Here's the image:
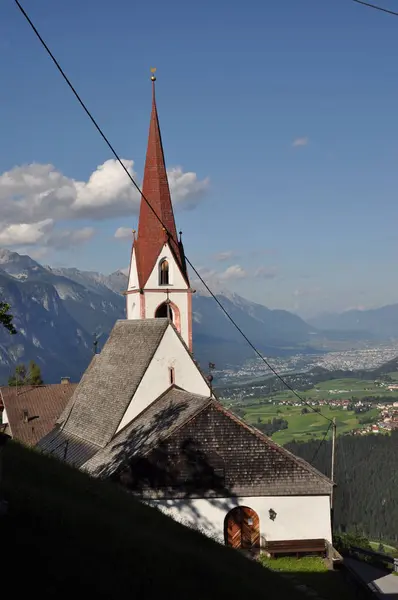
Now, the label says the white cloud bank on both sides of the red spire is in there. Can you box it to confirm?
[0,159,209,246]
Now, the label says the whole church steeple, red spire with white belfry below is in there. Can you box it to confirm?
[126,70,192,349]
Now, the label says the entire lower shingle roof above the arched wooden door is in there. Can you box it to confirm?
[82,387,333,498]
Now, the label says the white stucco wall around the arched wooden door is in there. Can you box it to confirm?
[148,496,332,543]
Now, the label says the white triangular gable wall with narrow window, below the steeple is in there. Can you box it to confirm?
[117,325,210,431]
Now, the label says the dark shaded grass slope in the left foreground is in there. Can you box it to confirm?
[0,442,304,600]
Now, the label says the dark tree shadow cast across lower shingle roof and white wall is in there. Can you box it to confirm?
[93,401,238,541]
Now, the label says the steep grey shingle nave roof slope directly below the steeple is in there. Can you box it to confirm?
[56,319,168,447]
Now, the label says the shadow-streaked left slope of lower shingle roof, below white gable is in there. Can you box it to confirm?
[84,386,211,477]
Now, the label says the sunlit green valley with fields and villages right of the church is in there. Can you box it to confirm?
[221,371,398,445]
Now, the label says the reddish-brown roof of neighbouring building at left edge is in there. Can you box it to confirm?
[0,383,77,446]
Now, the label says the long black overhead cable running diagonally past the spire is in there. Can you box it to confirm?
[15,0,332,422]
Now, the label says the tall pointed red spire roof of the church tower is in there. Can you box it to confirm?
[134,77,187,288]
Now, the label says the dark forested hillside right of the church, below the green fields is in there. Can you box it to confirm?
[286,431,398,542]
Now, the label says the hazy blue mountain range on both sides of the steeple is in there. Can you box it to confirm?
[0,249,398,383]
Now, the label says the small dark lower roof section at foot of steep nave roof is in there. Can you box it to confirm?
[36,428,100,468]
